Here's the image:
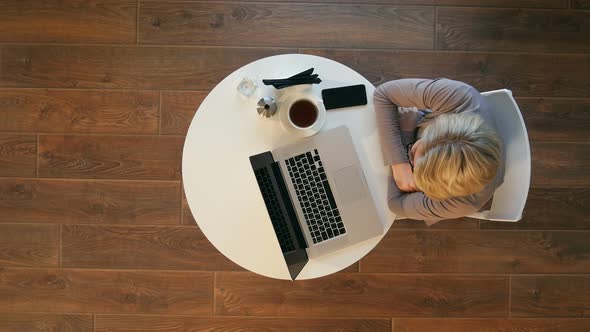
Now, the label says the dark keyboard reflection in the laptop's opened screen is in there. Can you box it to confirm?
[254,167,295,253]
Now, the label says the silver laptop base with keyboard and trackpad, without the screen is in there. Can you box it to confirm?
[272,126,383,258]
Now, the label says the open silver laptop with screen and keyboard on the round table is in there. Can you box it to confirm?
[250,126,384,280]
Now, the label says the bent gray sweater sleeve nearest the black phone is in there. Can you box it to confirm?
[373,78,477,165]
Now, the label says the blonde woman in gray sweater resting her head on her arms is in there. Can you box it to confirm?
[374,78,504,225]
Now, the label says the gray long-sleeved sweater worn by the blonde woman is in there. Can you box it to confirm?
[373,78,504,225]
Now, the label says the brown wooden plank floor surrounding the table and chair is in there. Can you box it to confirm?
[0,0,590,332]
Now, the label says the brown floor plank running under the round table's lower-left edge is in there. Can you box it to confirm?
[62,225,241,271]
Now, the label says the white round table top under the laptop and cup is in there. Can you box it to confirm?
[182,54,395,280]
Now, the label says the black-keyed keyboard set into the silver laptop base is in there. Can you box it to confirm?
[285,149,346,244]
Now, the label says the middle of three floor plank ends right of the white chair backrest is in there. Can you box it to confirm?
[531,142,590,186]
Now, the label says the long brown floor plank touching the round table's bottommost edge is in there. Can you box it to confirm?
[215,272,508,317]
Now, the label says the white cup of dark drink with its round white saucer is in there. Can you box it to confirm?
[279,91,326,137]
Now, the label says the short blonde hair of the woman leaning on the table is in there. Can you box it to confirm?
[414,113,501,200]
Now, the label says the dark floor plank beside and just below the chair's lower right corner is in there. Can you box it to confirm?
[480,187,590,230]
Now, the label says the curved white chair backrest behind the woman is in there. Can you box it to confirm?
[470,89,531,221]
